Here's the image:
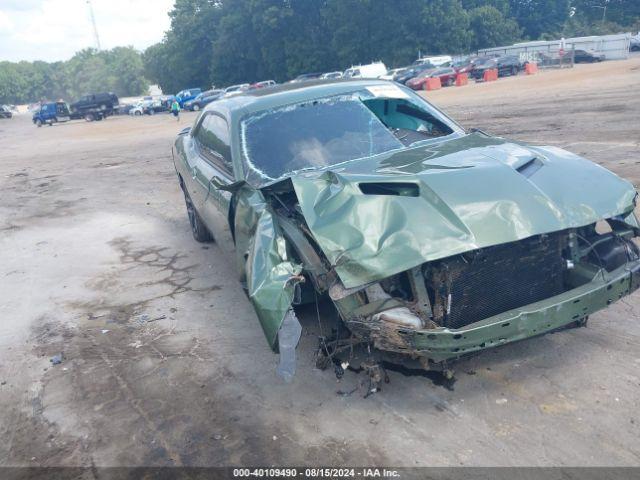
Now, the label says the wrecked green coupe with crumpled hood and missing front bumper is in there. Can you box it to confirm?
[174,80,640,378]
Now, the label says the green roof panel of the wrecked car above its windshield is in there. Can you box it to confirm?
[205,78,398,118]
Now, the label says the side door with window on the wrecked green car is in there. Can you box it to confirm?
[192,111,235,252]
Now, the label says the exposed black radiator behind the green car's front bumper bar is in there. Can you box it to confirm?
[424,232,567,328]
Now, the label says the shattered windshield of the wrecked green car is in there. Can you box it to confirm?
[241,86,457,184]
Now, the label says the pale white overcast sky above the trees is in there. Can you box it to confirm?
[0,0,174,62]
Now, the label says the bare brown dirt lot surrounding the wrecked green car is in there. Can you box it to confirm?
[0,57,640,466]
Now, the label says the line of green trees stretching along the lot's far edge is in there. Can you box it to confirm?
[0,0,640,103]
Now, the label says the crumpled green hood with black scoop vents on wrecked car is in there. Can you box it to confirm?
[291,133,636,288]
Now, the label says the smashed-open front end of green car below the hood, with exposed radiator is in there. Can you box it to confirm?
[329,219,640,368]
